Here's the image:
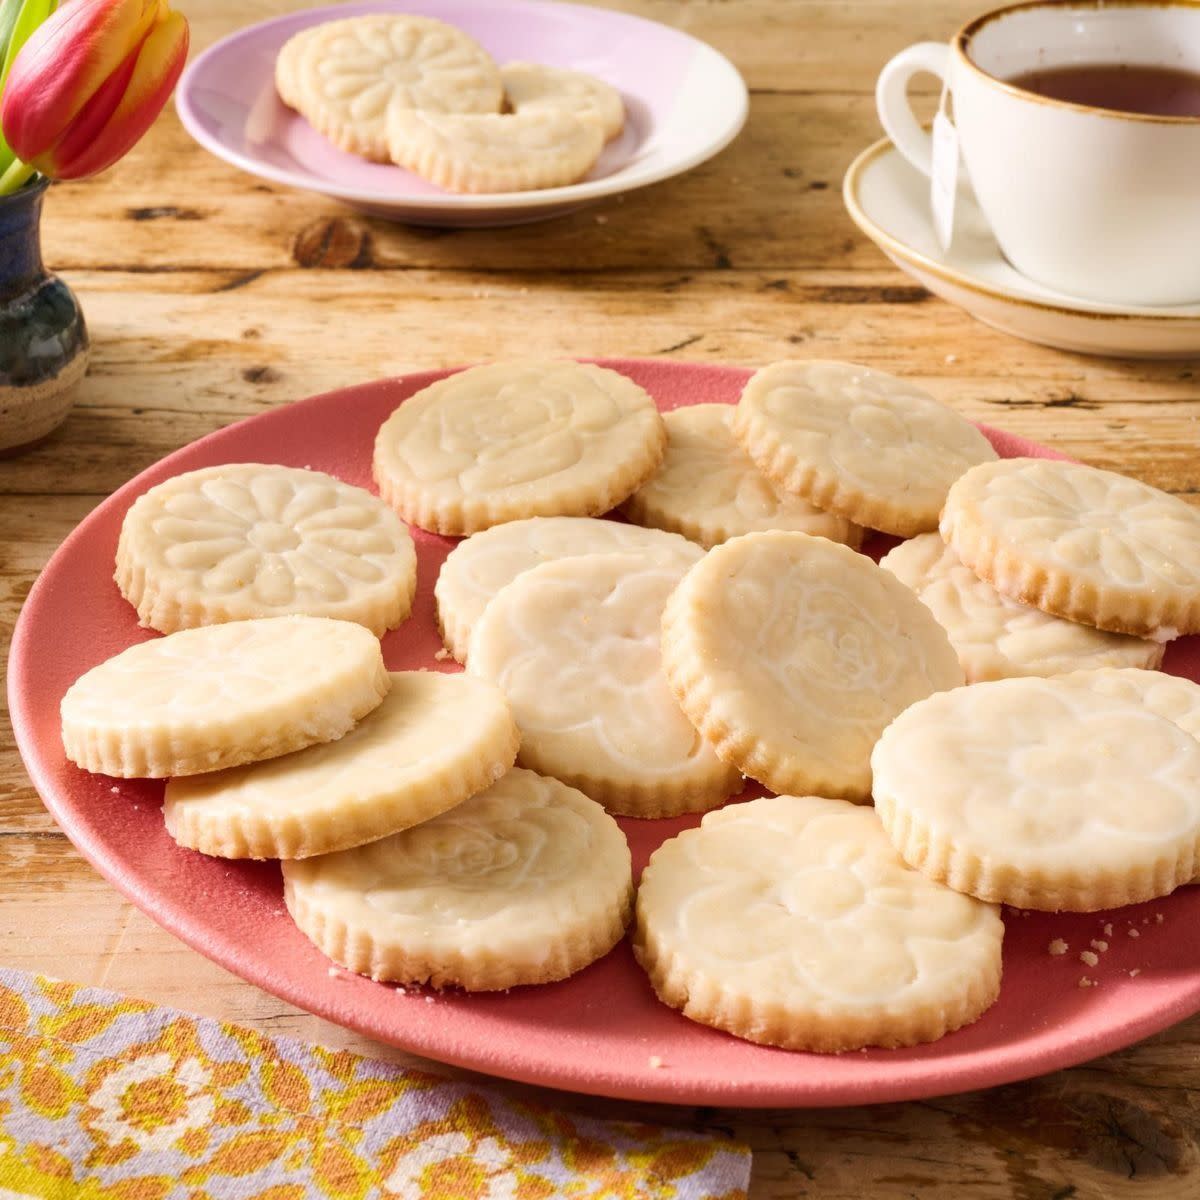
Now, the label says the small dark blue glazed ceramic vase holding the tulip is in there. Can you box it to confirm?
[0,179,88,455]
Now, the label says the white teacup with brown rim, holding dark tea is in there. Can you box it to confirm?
[875,0,1200,305]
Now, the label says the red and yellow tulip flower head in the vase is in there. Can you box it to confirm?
[0,0,187,191]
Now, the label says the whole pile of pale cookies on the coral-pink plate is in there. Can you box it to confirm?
[62,350,1200,1051]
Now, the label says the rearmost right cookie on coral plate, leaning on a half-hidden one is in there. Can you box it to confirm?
[733,359,996,538]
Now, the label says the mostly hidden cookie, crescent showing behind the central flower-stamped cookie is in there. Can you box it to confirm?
[433,517,697,662]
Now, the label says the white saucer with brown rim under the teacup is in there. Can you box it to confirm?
[842,138,1200,359]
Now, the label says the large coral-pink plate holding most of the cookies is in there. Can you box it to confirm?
[8,361,1200,1105]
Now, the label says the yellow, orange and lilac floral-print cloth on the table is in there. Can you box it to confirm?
[0,970,750,1200]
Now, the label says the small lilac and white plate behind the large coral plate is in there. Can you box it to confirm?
[175,0,748,226]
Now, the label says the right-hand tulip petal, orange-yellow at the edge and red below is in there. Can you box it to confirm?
[32,5,188,179]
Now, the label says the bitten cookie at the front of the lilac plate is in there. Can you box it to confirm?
[388,109,604,192]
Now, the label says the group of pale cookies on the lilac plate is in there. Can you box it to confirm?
[275,13,625,192]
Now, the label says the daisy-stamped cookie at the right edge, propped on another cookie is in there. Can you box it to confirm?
[941,458,1200,641]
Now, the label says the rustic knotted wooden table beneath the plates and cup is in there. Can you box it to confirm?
[0,0,1200,1200]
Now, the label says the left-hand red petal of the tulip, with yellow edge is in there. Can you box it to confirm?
[0,0,162,162]
